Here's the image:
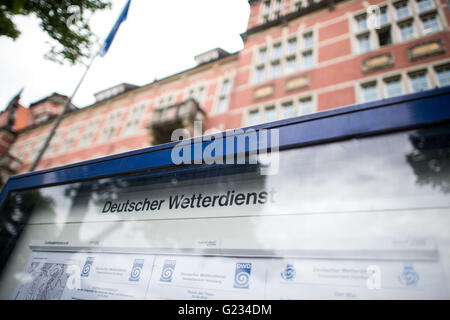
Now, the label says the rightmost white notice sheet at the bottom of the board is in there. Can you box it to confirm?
[266,259,448,299]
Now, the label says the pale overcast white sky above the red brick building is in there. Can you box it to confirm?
[0,0,250,110]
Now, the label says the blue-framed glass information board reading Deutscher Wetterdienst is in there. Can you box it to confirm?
[0,89,450,300]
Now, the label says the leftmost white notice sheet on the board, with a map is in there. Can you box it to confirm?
[13,252,154,300]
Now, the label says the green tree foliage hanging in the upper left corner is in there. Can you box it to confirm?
[0,0,111,64]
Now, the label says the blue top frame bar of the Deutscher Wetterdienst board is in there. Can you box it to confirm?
[0,86,450,204]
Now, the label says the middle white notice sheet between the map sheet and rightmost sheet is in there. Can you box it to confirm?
[149,256,267,300]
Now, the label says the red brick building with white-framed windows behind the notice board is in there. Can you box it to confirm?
[0,0,450,185]
